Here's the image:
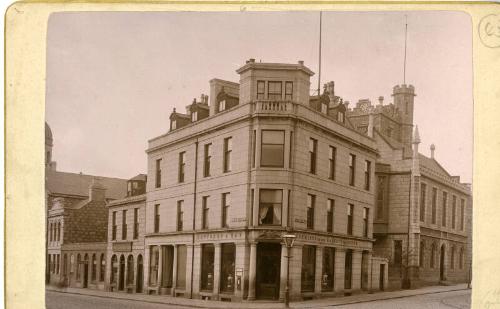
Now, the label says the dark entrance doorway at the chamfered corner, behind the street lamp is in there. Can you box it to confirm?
[255,243,281,299]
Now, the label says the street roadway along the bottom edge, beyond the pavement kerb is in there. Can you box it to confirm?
[46,290,471,309]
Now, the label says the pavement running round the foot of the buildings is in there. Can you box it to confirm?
[46,284,470,309]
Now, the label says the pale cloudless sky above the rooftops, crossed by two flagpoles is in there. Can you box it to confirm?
[46,11,473,182]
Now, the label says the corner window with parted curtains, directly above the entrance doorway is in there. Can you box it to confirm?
[259,189,283,225]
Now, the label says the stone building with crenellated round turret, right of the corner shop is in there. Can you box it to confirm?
[347,85,472,288]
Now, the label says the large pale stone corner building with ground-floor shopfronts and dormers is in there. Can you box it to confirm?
[144,59,387,300]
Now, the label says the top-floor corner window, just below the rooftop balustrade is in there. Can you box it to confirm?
[260,130,285,167]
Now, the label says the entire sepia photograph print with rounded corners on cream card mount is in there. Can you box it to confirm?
[44,10,476,309]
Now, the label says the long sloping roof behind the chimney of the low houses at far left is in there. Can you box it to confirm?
[46,170,127,199]
